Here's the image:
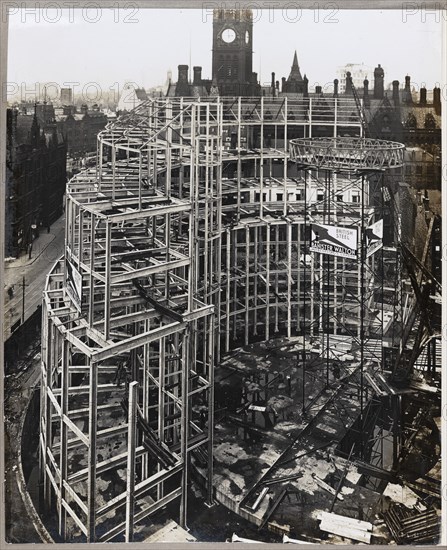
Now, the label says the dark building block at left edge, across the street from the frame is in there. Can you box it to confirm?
[5,108,67,257]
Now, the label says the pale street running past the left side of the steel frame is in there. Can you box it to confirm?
[3,214,65,341]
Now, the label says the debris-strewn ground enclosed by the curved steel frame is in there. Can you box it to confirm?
[210,339,439,544]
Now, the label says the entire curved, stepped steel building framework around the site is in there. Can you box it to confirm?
[40,98,408,541]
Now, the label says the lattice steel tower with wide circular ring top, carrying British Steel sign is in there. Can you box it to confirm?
[290,137,405,459]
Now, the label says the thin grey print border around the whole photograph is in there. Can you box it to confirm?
[0,0,447,550]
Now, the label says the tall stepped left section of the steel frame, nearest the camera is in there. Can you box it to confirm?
[41,101,221,541]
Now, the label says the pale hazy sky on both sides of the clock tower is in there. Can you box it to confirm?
[8,7,441,101]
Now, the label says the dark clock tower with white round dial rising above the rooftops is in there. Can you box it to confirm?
[212,9,259,96]
